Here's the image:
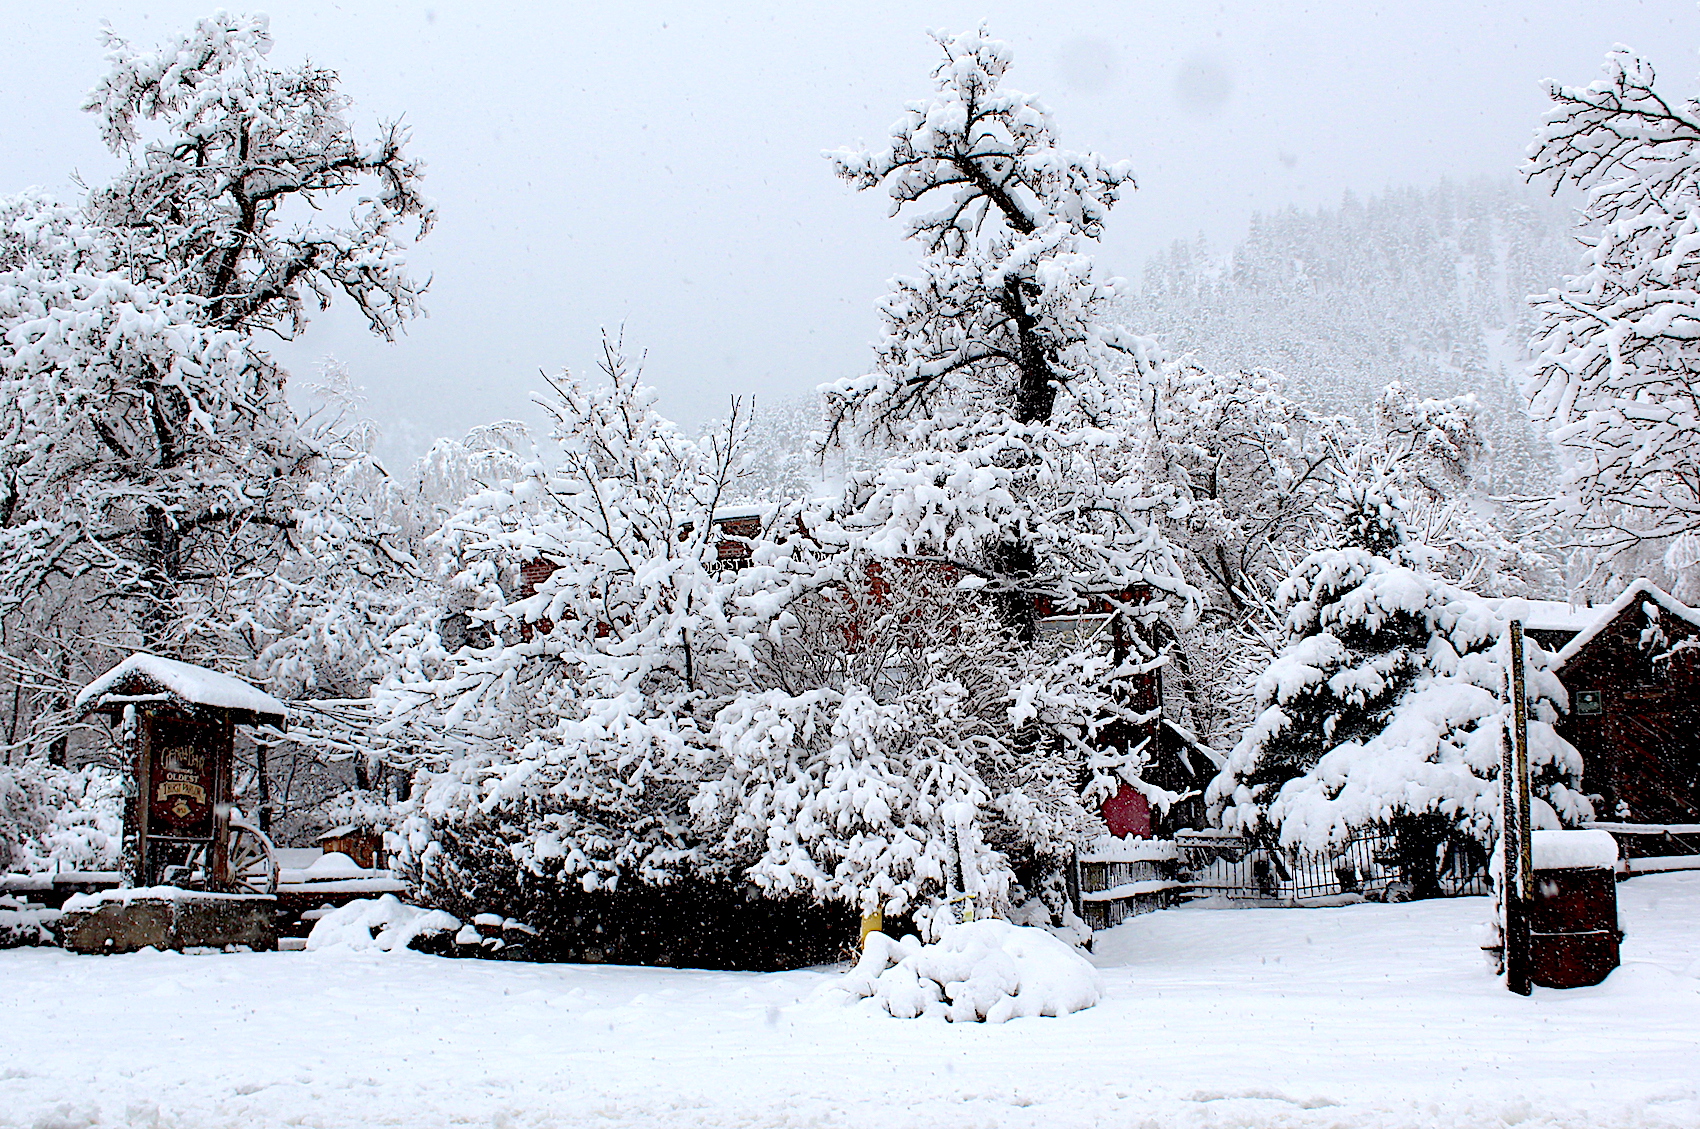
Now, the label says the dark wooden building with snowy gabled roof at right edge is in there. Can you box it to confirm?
[1528,580,1700,825]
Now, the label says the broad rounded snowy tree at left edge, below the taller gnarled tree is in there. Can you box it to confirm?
[0,197,302,663]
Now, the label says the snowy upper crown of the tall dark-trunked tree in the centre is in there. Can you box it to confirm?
[828,29,1153,445]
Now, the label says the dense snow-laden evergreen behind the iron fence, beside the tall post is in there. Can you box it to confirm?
[1207,462,1590,886]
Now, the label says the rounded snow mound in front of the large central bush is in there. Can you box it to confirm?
[840,920,1103,1024]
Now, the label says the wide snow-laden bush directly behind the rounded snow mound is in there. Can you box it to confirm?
[692,558,1115,935]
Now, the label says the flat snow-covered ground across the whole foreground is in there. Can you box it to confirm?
[0,874,1700,1129]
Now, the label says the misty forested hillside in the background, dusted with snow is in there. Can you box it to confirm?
[1127,179,1581,490]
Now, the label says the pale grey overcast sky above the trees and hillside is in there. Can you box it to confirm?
[0,0,1700,459]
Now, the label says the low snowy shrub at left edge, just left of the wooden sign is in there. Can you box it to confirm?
[0,763,124,874]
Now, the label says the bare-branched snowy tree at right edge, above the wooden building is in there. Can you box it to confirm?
[1525,48,1700,585]
